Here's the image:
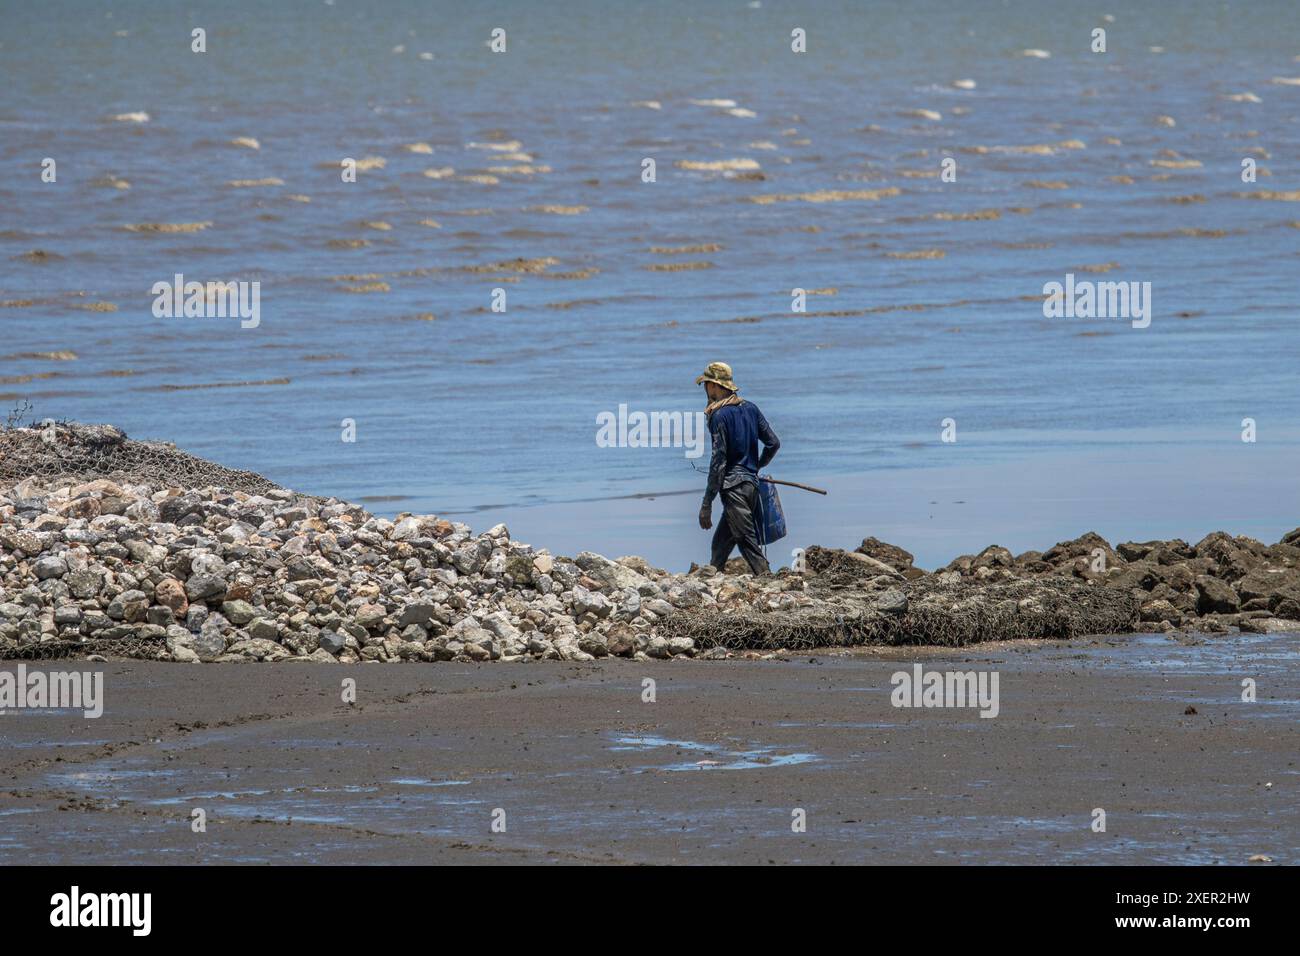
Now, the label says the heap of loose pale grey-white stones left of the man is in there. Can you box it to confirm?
[0,477,803,662]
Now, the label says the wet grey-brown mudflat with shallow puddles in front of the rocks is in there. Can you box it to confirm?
[0,635,1300,865]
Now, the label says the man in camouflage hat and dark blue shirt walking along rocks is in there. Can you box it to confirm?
[696,362,781,574]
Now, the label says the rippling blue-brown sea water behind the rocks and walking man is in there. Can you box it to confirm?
[0,0,1300,567]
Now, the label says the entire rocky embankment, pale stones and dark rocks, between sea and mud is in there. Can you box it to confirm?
[0,423,1300,663]
